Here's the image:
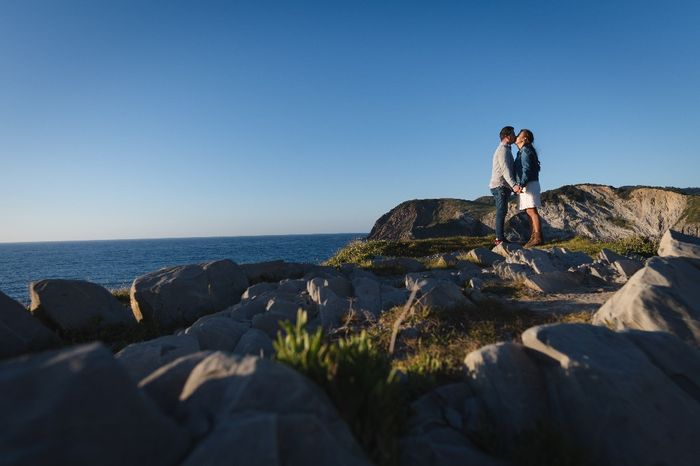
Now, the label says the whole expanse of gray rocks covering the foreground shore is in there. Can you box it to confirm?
[0,230,700,465]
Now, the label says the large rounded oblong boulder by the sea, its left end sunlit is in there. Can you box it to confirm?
[131,259,248,327]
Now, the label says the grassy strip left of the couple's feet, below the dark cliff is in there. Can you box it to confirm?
[325,236,495,267]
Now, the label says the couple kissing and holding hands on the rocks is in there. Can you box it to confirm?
[489,126,542,248]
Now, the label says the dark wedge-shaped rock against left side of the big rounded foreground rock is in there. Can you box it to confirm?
[138,351,212,417]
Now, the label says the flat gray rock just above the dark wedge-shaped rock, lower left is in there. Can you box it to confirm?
[114,335,200,382]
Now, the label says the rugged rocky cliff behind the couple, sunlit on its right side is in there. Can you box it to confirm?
[368,184,700,240]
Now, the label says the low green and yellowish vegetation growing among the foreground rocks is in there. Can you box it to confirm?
[274,301,591,465]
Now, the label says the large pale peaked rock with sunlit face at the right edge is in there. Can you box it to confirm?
[593,257,700,345]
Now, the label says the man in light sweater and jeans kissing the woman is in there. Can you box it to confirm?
[489,126,520,246]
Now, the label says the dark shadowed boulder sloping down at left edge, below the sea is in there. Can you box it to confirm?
[0,291,59,358]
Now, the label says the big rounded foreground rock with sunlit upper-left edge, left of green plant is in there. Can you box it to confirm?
[179,353,368,465]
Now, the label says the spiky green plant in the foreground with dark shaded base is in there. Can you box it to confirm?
[274,311,407,465]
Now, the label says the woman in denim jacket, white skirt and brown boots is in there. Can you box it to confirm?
[513,129,542,248]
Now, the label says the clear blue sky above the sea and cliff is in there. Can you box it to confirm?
[0,0,700,242]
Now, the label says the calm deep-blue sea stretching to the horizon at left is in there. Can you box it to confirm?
[0,233,366,304]
